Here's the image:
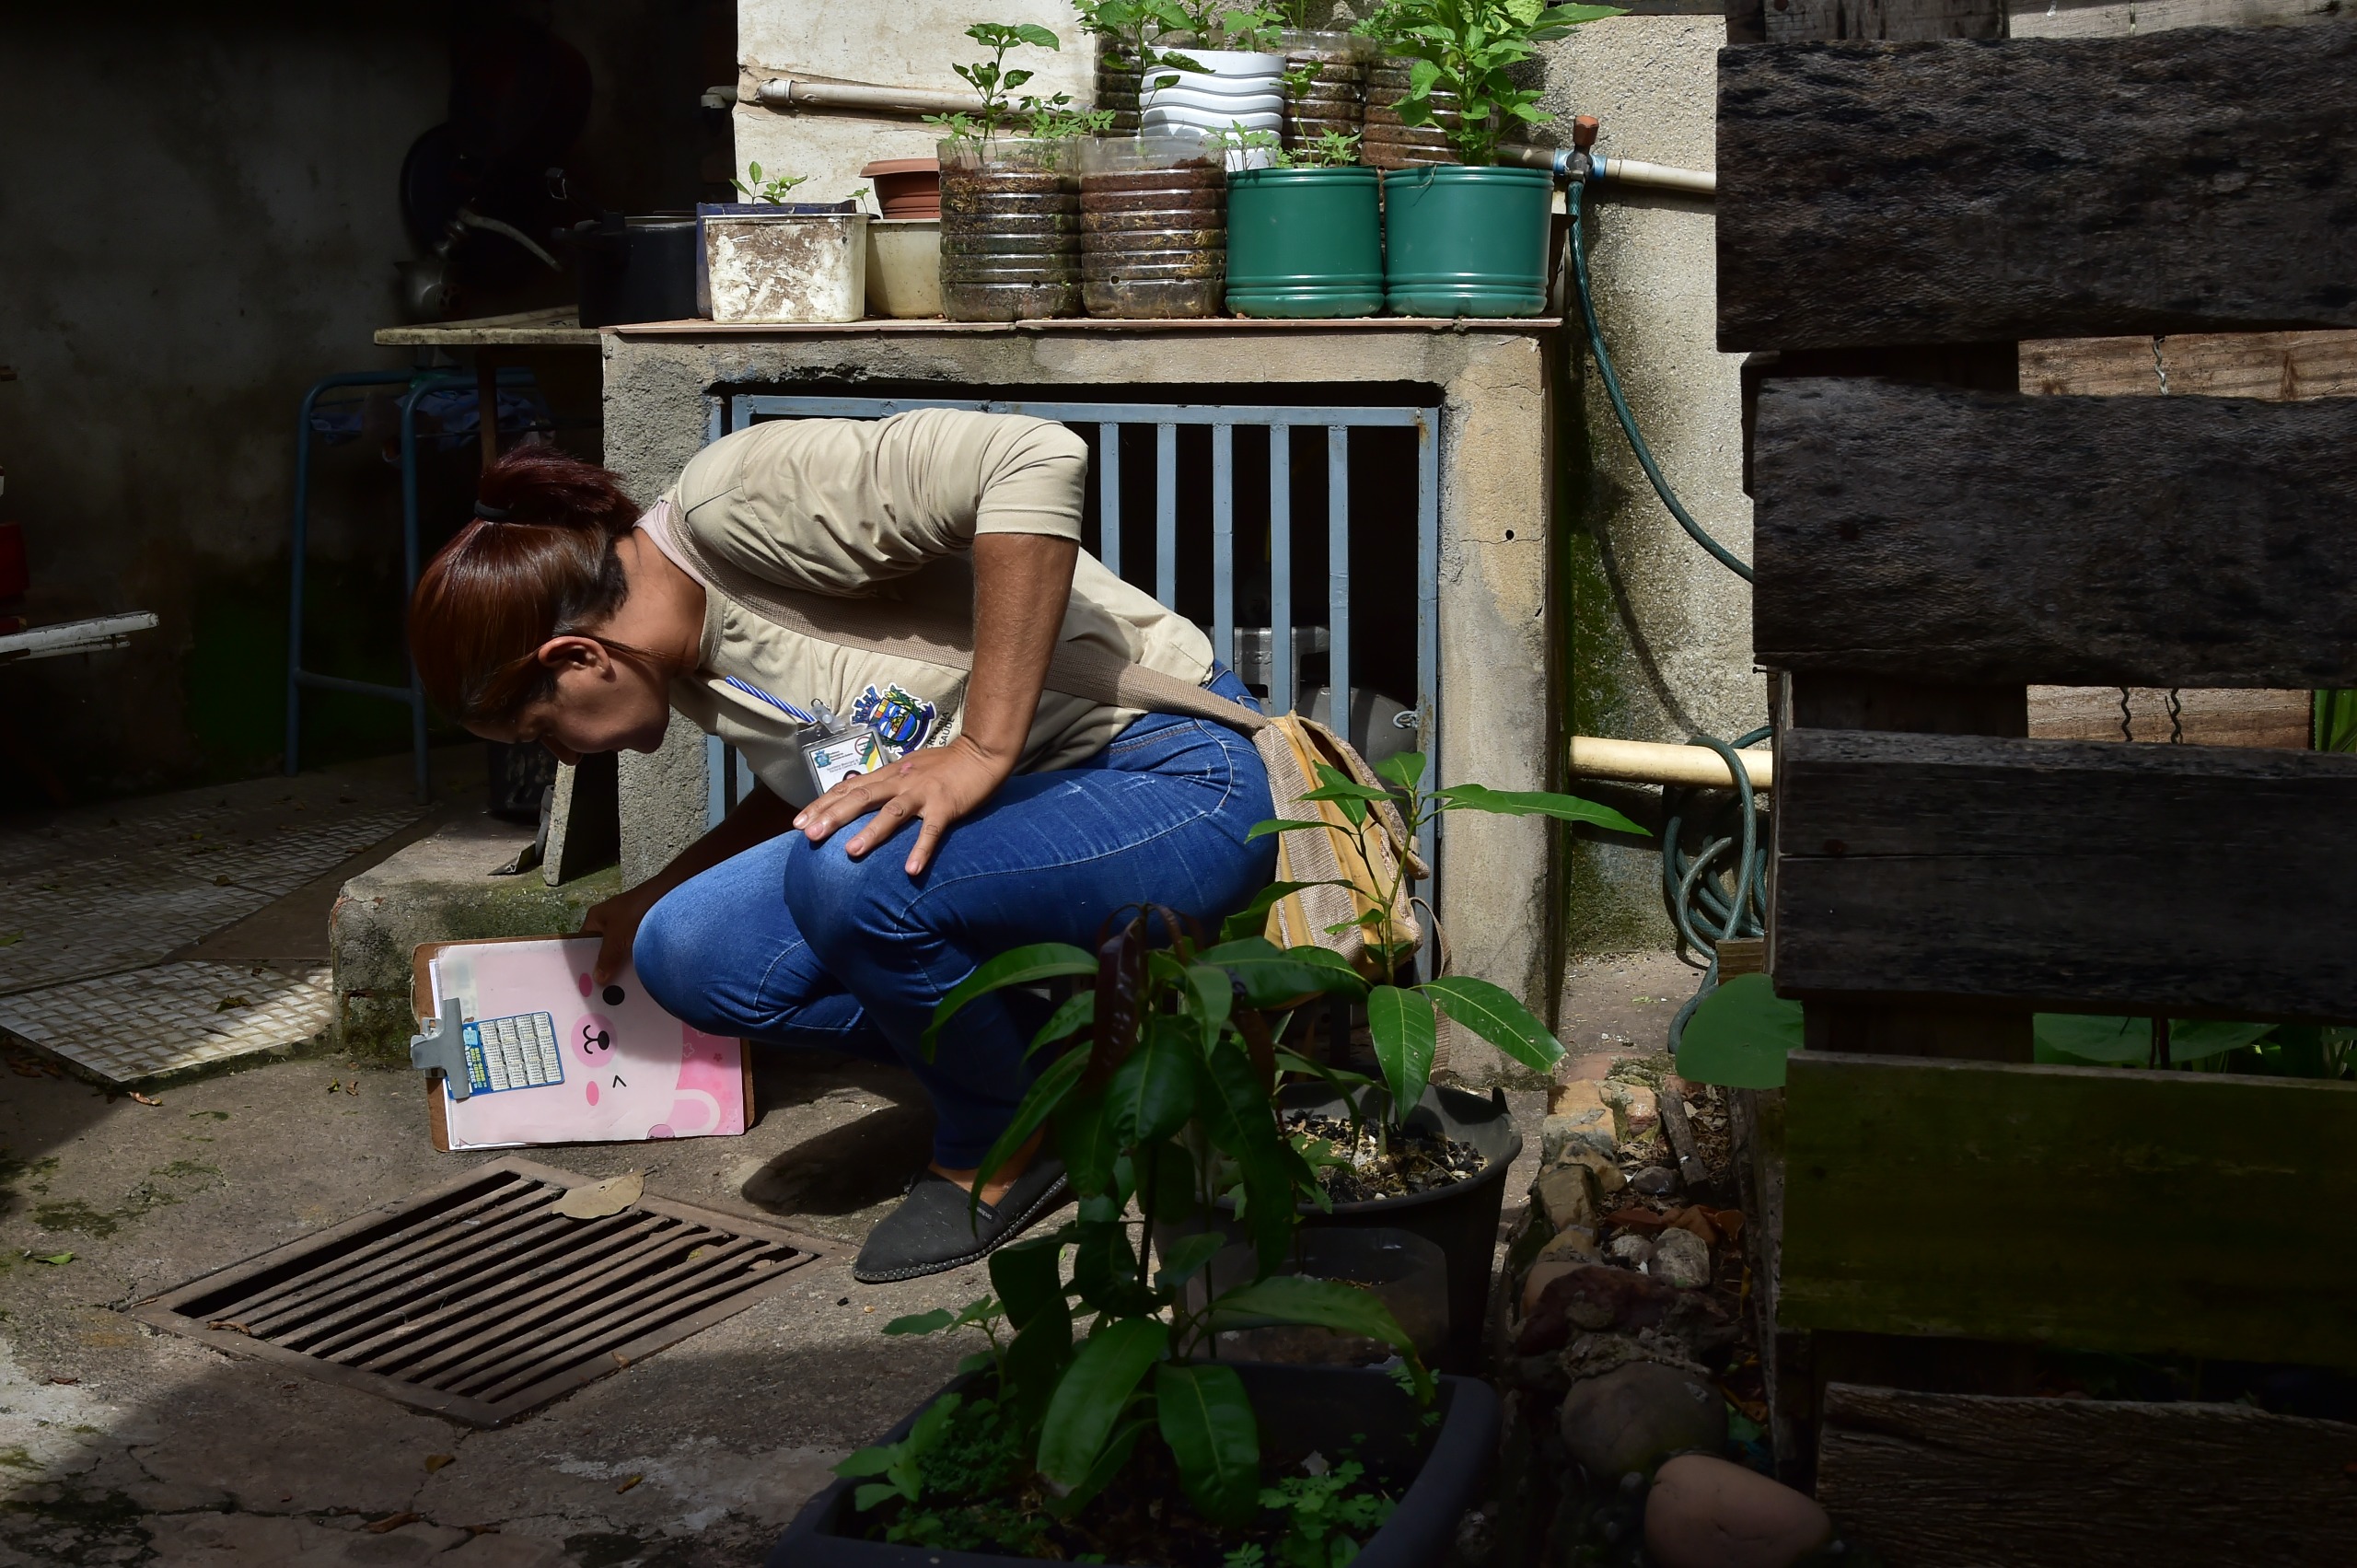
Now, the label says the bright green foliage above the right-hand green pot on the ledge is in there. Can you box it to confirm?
[1358,0,1626,165]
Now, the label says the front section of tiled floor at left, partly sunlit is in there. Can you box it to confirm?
[0,964,335,1082]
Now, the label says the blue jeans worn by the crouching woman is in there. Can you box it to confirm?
[632,672,1278,1169]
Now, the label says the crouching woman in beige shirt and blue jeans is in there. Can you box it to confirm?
[410,411,1275,1281]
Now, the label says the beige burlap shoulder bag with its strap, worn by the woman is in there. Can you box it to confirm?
[651,507,1431,979]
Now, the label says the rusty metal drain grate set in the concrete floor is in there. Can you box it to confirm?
[132,1157,816,1426]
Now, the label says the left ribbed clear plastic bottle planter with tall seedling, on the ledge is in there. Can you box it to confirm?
[926,21,1110,320]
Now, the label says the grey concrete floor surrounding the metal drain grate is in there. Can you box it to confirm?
[0,759,1690,1568]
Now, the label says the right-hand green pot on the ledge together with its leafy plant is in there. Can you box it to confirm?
[1372,0,1624,316]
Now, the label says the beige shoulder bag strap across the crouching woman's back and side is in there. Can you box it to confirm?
[653,507,1268,733]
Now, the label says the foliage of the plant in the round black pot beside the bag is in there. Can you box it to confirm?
[1224,752,1650,1127]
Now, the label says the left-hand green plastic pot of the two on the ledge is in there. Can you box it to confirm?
[1228,168,1384,319]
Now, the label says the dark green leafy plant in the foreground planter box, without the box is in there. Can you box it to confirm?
[839,911,1431,1533]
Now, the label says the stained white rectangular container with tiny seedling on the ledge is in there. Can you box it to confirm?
[695,163,867,320]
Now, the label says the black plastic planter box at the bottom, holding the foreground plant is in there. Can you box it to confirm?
[769,1361,1497,1568]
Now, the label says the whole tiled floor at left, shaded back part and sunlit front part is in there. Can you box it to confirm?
[0,752,447,1082]
